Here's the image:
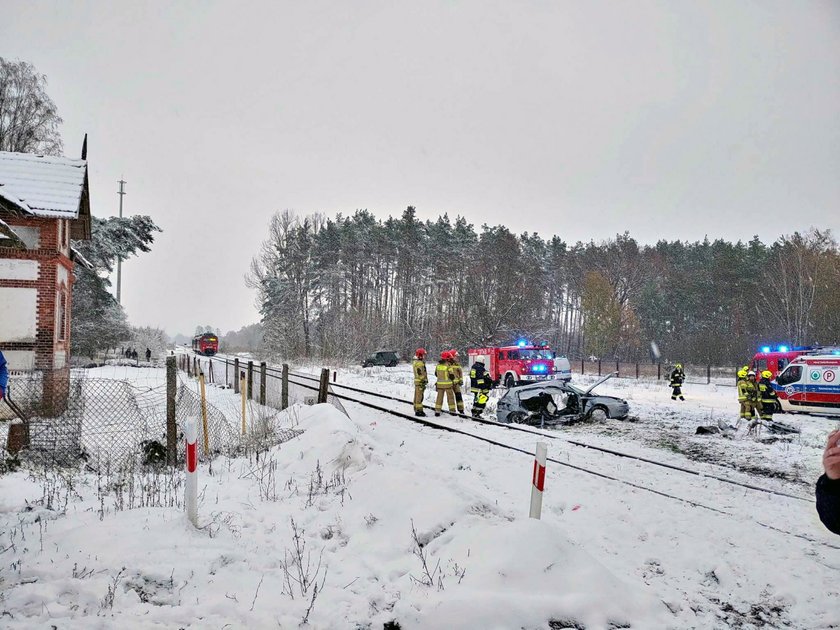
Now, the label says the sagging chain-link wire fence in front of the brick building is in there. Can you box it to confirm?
[0,369,299,467]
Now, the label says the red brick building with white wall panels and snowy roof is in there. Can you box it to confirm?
[0,149,90,386]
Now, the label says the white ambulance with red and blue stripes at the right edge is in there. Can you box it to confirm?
[773,358,840,416]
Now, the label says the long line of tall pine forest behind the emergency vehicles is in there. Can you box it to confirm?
[247,207,840,364]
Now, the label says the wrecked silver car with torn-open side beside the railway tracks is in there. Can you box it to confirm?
[496,372,630,427]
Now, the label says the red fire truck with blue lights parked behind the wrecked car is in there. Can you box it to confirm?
[467,339,572,387]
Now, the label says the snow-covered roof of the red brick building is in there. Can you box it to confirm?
[0,151,90,239]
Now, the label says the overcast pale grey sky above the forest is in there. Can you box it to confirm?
[0,0,840,334]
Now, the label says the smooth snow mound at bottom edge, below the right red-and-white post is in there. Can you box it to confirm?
[396,519,664,630]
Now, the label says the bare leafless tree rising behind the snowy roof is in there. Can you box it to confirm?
[0,57,63,155]
